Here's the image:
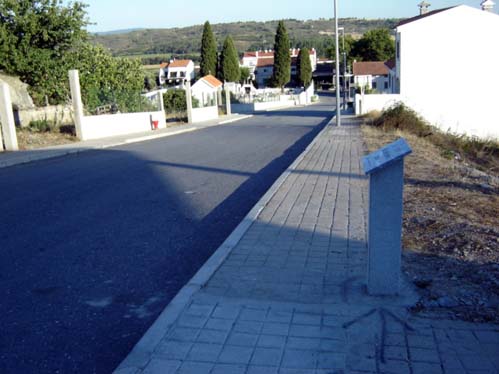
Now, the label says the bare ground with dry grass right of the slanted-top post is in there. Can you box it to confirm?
[363,126,499,323]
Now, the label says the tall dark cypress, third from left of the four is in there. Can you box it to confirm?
[272,21,291,90]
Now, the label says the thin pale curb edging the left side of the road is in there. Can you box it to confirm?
[0,115,252,169]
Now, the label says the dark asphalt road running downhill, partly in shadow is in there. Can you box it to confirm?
[0,95,333,374]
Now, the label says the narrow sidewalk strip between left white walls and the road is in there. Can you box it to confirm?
[0,114,248,168]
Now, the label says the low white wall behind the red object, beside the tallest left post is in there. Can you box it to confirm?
[81,111,166,140]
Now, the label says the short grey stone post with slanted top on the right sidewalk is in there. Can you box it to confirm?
[363,139,412,295]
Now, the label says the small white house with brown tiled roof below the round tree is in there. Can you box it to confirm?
[353,61,393,93]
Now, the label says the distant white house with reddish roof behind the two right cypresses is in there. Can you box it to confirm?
[241,48,317,87]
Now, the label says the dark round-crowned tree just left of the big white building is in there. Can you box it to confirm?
[352,29,395,61]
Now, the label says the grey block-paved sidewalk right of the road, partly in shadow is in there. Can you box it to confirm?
[116,118,499,374]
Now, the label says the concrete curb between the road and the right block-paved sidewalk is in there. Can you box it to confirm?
[114,116,335,374]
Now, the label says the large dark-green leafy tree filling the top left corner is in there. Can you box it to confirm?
[0,0,88,103]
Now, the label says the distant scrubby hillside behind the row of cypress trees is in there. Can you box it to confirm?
[92,18,400,57]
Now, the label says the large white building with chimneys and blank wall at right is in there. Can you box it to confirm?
[393,0,499,138]
